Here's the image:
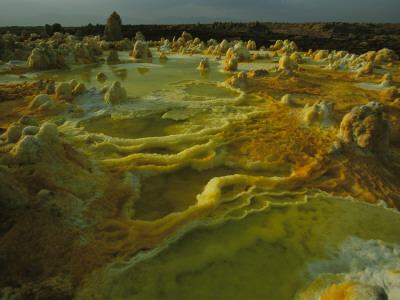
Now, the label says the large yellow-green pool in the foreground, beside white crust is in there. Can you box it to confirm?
[78,192,400,300]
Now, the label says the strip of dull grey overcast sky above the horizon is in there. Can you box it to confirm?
[0,0,400,26]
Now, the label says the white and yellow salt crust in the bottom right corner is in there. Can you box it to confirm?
[298,238,400,300]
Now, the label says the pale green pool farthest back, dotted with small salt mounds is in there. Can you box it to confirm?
[33,52,225,97]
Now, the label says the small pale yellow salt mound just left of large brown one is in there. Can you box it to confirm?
[302,101,335,127]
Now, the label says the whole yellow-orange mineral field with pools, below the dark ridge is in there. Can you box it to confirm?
[0,24,400,300]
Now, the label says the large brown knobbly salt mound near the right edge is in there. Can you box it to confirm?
[340,102,391,157]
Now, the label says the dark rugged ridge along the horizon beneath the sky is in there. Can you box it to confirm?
[0,22,400,55]
